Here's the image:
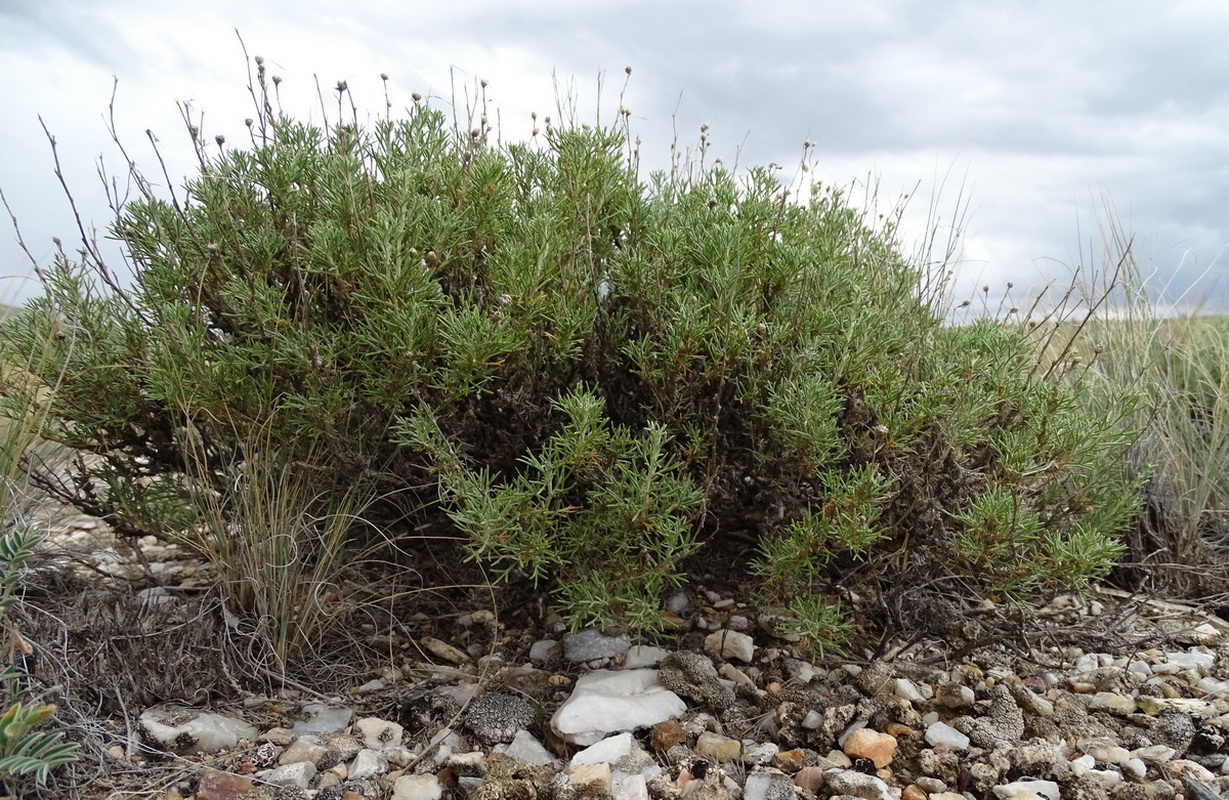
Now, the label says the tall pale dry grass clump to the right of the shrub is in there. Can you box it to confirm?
[1041,210,1229,598]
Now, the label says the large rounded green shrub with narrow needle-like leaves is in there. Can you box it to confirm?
[7,84,1134,643]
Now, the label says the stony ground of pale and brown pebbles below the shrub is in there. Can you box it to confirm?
[14,517,1229,800]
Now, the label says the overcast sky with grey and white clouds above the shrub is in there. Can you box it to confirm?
[0,0,1229,317]
